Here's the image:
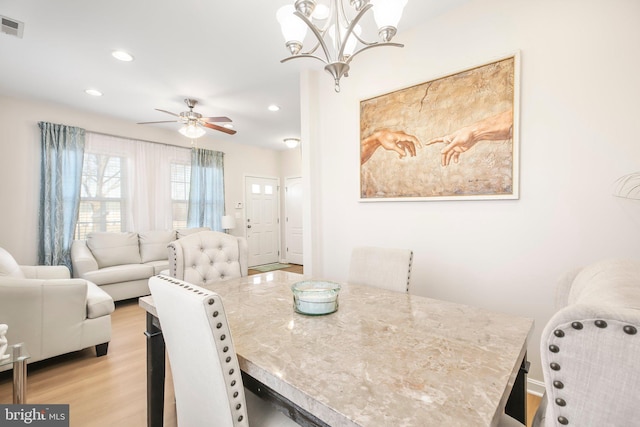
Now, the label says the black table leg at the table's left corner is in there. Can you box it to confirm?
[145,313,165,427]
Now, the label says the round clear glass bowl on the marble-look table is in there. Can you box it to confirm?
[291,280,340,316]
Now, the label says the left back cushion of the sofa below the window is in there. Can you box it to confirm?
[87,232,142,268]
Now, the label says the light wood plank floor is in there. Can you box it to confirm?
[0,266,540,427]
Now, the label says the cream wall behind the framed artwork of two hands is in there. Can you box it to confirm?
[302,0,640,390]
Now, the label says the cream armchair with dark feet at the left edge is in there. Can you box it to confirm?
[0,248,114,371]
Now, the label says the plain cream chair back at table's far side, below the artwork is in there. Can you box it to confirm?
[348,246,413,292]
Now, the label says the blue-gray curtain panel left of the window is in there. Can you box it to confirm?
[38,122,85,270]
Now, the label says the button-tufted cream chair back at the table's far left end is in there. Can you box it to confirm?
[168,231,249,286]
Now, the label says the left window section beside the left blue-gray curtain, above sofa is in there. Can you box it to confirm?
[75,153,126,239]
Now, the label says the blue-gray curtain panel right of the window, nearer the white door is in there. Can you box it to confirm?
[187,148,224,231]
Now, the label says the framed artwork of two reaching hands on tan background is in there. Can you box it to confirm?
[360,53,520,201]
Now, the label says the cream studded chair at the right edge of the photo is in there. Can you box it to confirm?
[533,260,640,427]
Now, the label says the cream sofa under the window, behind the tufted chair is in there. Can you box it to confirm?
[71,227,209,301]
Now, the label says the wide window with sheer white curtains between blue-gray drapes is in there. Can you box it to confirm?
[74,132,191,239]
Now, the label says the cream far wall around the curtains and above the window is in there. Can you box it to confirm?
[0,96,281,264]
